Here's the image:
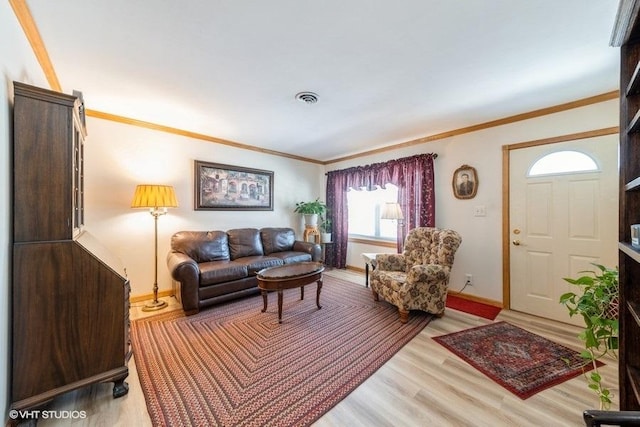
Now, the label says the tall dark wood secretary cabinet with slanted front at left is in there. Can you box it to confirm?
[11,82,131,410]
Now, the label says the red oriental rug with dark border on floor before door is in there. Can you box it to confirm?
[434,322,591,399]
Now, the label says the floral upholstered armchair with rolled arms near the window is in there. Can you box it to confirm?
[371,227,462,323]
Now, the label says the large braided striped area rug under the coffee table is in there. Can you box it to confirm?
[131,276,432,427]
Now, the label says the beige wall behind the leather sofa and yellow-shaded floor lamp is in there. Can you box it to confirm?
[85,116,324,296]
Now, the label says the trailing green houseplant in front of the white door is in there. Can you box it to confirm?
[560,264,619,409]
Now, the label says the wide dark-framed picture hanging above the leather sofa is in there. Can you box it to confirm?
[194,160,273,211]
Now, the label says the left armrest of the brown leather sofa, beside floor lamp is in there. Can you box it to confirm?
[167,251,200,314]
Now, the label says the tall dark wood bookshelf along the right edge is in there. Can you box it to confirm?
[611,0,640,411]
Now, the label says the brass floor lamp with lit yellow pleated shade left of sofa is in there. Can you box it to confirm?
[131,184,178,311]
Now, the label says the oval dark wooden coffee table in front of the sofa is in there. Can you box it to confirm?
[257,262,324,323]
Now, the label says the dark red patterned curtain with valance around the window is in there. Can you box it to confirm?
[325,153,438,268]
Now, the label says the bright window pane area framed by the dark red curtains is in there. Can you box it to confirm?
[347,184,398,241]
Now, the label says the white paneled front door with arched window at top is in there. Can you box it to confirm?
[509,135,618,325]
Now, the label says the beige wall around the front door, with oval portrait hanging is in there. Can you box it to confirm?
[327,100,618,301]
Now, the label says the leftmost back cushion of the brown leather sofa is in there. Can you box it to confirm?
[171,231,230,263]
